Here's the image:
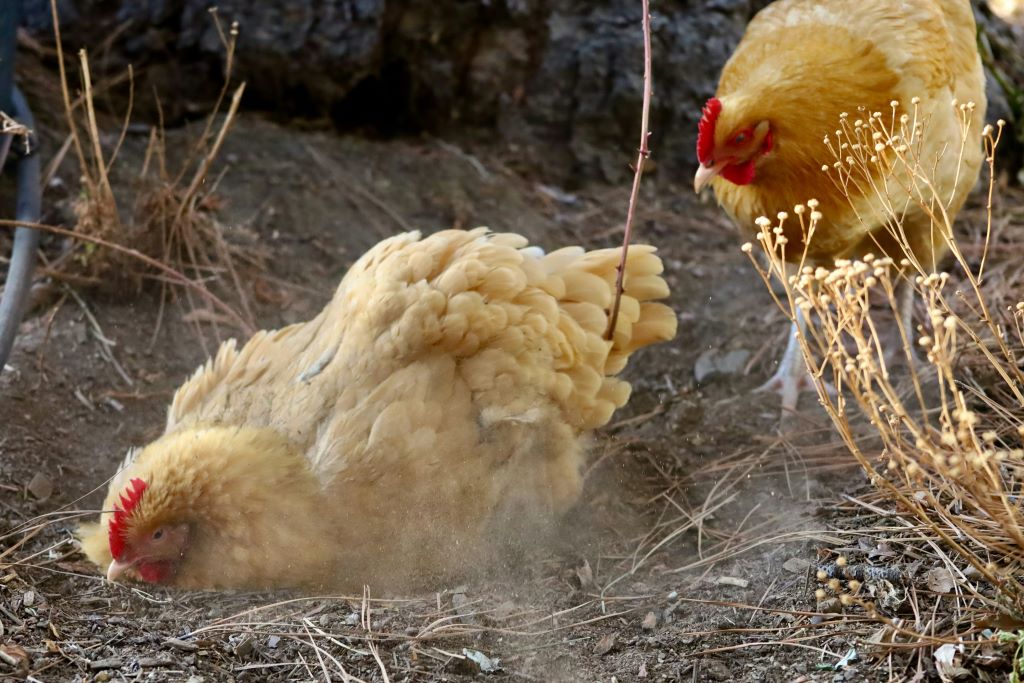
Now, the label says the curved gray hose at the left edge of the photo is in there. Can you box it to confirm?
[0,89,42,372]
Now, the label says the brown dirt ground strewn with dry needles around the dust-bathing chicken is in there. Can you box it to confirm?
[0,111,999,683]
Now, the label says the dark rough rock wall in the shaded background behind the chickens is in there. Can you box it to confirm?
[16,0,1024,184]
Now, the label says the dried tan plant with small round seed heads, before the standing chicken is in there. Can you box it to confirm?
[744,97,1024,667]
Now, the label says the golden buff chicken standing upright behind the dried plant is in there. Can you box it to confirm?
[693,0,985,411]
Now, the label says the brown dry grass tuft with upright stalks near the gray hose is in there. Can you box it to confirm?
[45,1,261,338]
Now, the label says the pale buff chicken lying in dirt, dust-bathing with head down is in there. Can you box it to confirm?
[81,228,676,589]
